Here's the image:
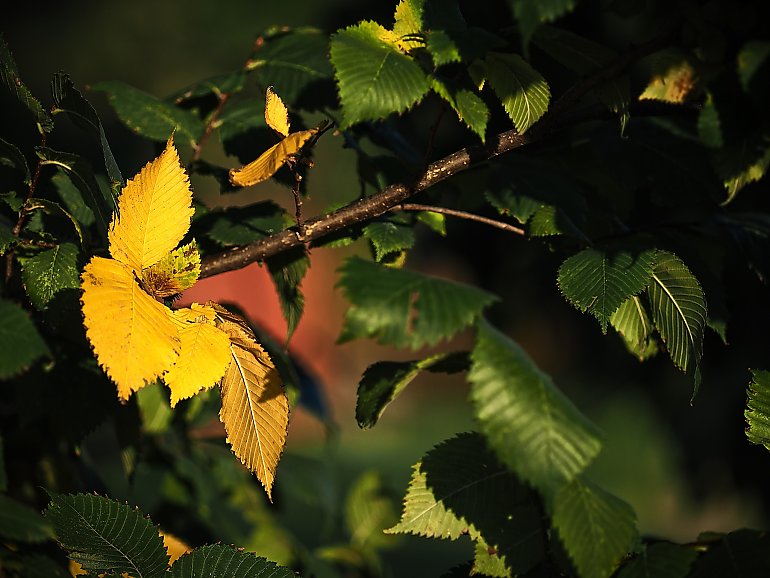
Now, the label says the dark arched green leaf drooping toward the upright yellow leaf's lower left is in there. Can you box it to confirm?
[36,147,117,245]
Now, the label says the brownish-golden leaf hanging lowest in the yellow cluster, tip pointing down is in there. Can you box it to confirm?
[214,306,289,500]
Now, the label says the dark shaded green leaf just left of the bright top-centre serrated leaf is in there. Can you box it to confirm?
[249,27,332,109]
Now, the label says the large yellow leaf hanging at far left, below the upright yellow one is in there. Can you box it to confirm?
[81,257,179,400]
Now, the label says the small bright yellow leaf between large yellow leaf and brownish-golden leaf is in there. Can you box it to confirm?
[163,303,230,407]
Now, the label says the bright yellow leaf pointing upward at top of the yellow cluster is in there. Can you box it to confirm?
[109,136,193,271]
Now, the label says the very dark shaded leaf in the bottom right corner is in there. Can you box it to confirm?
[688,530,770,578]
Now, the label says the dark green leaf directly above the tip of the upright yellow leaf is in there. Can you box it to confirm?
[91,80,203,145]
